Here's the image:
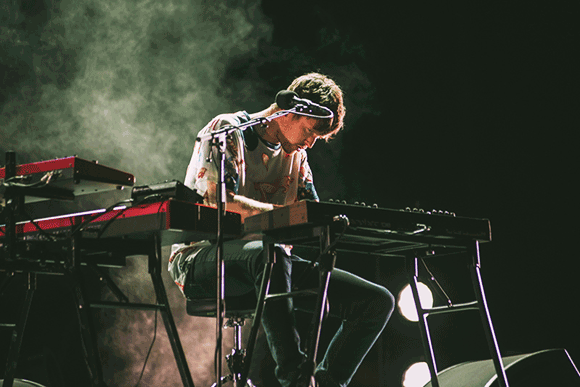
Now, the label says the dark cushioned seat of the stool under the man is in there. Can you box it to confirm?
[186,292,258,318]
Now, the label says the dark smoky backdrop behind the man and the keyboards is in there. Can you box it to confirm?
[0,0,580,386]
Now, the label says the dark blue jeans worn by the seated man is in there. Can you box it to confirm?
[186,240,395,387]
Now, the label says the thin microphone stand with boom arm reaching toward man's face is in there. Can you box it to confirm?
[196,108,300,387]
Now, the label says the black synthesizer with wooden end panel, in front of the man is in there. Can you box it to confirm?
[244,200,491,254]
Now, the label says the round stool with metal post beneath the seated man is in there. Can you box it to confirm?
[186,292,257,387]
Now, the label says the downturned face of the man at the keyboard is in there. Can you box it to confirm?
[278,116,322,154]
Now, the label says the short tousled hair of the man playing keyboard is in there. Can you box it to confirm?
[288,73,346,141]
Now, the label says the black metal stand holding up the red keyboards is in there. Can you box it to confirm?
[0,234,194,387]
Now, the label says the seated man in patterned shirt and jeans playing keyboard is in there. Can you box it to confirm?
[169,73,394,387]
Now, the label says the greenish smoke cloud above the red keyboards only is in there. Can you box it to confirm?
[0,0,270,183]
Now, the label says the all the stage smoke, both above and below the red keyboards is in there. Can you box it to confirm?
[0,0,271,386]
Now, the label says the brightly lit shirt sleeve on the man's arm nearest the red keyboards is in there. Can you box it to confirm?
[184,116,242,199]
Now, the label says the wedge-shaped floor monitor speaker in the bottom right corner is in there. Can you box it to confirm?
[424,349,580,387]
